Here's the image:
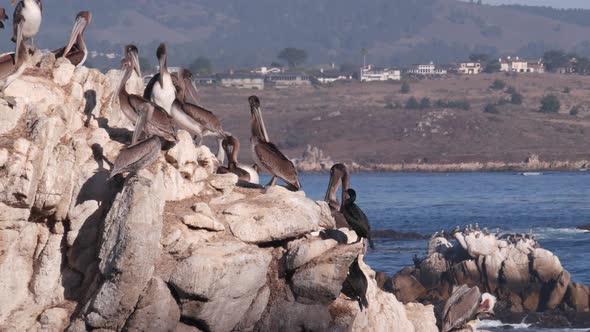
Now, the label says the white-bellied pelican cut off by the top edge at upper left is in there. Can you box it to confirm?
[12,0,43,58]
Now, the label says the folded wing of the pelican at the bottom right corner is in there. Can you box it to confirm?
[442,285,481,332]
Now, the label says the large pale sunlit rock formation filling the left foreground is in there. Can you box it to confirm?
[0,56,438,331]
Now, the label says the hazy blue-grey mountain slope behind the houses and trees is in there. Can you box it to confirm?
[16,0,590,70]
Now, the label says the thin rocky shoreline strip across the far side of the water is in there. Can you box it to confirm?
[298,160,590,173]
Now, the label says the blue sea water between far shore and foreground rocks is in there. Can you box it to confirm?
[294,172,590,284]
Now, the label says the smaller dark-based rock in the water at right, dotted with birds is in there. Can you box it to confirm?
[383,229,590,327]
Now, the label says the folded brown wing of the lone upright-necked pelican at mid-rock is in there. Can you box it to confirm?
[254,142,301,189]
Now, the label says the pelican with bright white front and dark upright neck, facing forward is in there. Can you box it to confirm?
[143,43,176,114]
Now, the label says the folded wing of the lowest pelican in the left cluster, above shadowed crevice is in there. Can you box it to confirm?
[110,136,162,178]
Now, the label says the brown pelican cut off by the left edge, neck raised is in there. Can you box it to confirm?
[0,16,29,90]
